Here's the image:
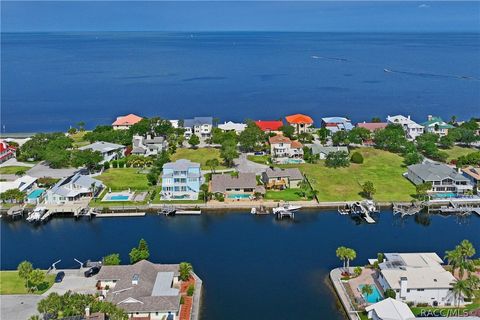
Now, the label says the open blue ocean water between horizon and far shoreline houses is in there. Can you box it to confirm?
[1,32,480,132]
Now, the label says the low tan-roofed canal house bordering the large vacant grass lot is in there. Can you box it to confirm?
[262,167,303,190]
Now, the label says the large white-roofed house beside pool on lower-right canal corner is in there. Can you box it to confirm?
[377,252,463,306]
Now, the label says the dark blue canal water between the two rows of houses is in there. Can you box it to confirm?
[0,211,480,320]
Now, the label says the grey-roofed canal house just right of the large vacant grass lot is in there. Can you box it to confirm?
[407,162,473,195]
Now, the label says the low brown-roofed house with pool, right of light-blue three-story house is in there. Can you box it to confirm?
[209,172,265,200]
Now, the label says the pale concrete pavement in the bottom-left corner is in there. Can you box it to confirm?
[0,294,43,320]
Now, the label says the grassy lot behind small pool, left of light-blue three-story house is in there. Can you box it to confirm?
[96,168,149,191]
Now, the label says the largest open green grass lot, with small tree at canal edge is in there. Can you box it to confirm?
[282,148,415,201]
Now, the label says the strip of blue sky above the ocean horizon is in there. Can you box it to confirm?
[1,0,480,32]
